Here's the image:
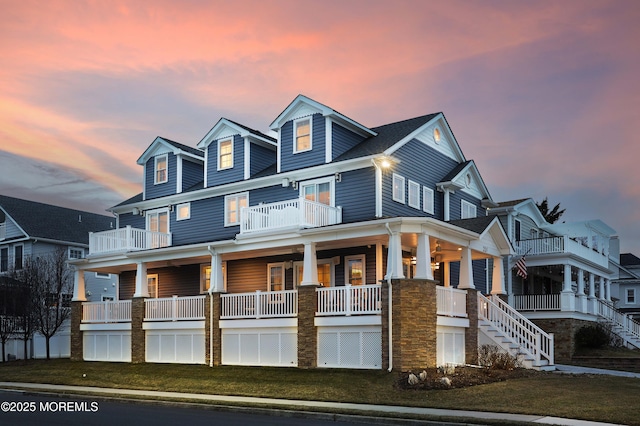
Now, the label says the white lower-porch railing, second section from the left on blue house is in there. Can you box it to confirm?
[144,295,205,321]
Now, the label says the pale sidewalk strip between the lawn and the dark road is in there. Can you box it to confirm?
[0,382,624,426]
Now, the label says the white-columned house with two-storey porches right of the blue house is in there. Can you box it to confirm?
[489,198,640,361]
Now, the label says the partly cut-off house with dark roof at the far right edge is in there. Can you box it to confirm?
[612,253,640,320]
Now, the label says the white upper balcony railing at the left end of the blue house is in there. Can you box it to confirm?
[89,226,171,254]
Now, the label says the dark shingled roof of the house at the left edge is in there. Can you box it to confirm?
[0,195,116,245]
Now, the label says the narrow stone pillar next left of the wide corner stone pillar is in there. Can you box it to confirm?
[298,285,318,368]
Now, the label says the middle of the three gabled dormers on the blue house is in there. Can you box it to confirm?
[198,118,276,188]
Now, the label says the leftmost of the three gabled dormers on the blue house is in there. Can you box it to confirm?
[137,136,204,200]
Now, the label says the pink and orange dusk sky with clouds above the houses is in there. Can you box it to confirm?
[0,0,640,255]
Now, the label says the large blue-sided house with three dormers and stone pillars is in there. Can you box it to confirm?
[71,95,576,370]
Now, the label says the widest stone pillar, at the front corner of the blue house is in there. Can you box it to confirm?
[382,279,438,371]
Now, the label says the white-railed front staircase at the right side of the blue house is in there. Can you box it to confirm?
[478,293,555,370]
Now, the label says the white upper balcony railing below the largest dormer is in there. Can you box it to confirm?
[240,198,342,234]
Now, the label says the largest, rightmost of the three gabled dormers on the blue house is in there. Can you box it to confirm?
[270,95,376,173]
